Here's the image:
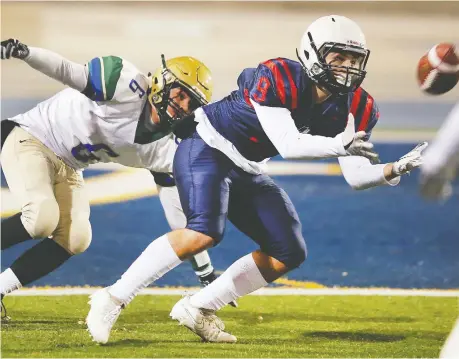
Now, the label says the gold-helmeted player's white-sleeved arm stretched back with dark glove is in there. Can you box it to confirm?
[1,39,88,92]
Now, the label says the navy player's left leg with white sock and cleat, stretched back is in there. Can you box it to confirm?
[86,134,233,343]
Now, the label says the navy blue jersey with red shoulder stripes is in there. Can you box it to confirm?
[203,58,379,162]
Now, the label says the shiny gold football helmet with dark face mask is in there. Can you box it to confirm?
[148,55,213,126]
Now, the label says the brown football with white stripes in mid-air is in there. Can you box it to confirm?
[418,43,459,95]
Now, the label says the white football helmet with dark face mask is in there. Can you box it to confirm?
[297,15,370,94]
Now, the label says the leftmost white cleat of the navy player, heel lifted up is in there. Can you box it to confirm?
[86,288,123,344]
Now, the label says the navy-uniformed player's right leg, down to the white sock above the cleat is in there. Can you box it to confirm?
[173,176,306,335]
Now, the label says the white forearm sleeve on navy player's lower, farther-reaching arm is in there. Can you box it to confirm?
[338,156,400,190]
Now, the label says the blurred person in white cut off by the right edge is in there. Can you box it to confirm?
[421,102,459,358]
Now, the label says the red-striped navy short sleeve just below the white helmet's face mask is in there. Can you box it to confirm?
[349,87,379,141]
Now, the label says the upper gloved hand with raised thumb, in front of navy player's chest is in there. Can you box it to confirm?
[341,113,379,163]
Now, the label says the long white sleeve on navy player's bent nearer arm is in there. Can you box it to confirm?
[250,99,346,159]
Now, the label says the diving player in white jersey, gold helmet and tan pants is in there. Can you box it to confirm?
[0,39,235,320]
